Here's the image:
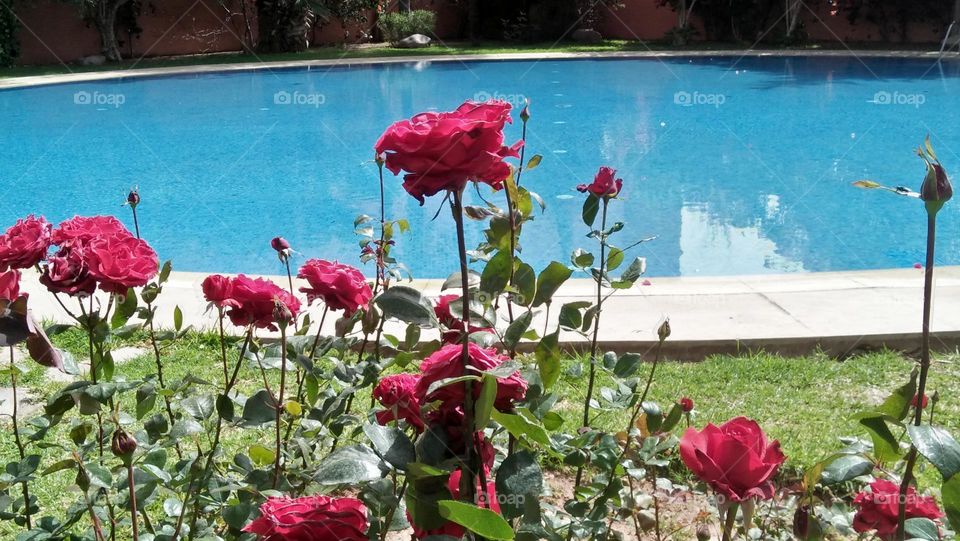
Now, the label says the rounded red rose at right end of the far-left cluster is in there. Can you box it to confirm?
[83,234,160,295]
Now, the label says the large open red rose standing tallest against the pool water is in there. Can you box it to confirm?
[374,101,522,205]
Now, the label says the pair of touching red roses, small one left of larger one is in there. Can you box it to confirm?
[202,274,300,330]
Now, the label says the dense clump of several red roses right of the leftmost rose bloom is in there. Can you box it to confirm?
[40,216,160,296]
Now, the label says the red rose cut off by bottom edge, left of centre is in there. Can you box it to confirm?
[243,496,368,541]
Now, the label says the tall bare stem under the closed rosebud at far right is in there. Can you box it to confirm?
[896,211,937,541]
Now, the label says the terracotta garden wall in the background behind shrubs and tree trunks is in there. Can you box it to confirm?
[17,0,943,64]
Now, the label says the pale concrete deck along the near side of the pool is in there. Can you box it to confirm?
[16,266,960,360]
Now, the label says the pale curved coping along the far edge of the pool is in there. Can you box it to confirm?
[0,49,956,90]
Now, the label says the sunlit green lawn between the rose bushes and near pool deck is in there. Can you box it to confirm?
[0,331,960,538]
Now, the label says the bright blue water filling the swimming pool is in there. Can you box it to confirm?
[0,57,960,278]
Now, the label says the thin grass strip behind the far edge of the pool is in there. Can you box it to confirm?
[0,40,944,79]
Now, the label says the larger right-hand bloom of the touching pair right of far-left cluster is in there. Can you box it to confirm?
[227,274,300,330]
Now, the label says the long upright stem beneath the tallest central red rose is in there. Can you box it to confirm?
[451,189,486,501]
